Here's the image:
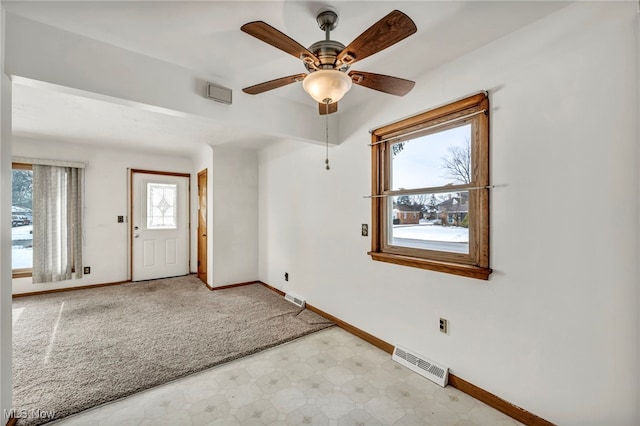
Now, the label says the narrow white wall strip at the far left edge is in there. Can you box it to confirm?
[0,2,13,425]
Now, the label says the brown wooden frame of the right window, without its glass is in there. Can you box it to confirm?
[369,93,491,280]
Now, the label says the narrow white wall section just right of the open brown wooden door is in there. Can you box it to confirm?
[209,146,258,287]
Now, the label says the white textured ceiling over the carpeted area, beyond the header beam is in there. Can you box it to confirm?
[12,84,282,155]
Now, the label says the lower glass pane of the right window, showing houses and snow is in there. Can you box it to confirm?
[388,191,469,254]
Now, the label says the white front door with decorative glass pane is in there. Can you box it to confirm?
[131,171,189,281]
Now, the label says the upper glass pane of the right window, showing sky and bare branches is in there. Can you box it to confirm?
[391,124,471,190]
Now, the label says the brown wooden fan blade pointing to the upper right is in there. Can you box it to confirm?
[338,10,418,64]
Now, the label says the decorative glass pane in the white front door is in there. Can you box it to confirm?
[147,183,178,229]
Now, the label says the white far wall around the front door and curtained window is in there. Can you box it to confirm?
[13,138,192,294]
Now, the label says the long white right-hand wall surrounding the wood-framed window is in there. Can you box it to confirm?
[259,2,640,425]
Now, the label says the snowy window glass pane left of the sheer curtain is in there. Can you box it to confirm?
[11,169,33,269]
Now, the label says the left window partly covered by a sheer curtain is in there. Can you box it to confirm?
[11,157,84,283]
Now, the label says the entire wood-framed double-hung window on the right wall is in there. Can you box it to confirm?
[369,94,491,279]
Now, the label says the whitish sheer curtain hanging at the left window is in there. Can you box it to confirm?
[33,164,84,283]
